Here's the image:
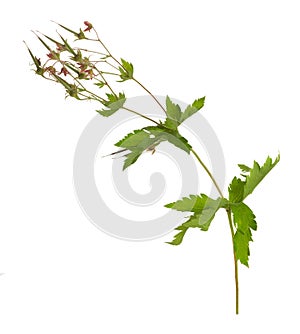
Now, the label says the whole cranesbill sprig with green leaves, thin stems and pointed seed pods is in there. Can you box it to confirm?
[27,21,280,314]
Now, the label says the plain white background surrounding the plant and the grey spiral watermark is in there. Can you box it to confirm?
[0,0,300,334]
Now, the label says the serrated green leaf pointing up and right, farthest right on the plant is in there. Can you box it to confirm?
[242,155,280,198]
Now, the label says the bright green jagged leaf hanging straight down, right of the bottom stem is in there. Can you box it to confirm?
[231,203,257,267]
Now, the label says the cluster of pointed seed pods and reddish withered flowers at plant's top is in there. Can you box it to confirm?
[27,21,133,108]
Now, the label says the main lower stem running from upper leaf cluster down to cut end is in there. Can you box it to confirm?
[191,149,239,314]
